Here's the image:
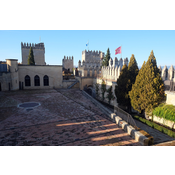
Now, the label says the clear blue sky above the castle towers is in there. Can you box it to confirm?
[0,30,175,66]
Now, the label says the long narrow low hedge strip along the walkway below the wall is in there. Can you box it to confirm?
[133,116,175,138]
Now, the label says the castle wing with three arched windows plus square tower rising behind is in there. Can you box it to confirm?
[0,43,66,91]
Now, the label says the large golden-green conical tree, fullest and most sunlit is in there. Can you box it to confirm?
[129,51,164,115]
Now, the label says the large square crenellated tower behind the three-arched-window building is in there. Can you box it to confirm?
[21,42,46,65]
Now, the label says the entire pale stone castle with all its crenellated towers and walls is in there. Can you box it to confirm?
[0,43,175,106]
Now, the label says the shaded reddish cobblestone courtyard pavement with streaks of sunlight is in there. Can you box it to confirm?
[0,89,141,146]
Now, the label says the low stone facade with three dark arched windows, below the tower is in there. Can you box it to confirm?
[0,59,63,91]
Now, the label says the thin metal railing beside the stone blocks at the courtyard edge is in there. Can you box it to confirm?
[114,106,138,130]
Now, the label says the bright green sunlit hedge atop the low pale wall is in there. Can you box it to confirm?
[153,104,175,122]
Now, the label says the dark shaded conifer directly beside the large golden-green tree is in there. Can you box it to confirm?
[115,64,130,106]
